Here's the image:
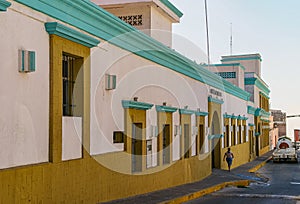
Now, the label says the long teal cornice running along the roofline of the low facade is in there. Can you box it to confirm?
[15,0,251,101]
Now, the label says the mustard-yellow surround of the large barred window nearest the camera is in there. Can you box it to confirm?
[49,35,90,162]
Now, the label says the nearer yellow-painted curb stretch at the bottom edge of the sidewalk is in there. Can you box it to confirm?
[160,180,250,204]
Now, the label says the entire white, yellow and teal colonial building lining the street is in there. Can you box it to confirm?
[0,0,270,203]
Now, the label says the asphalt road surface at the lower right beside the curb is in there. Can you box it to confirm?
[187,153,300,204]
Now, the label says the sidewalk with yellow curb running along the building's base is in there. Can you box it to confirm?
[102,151,273,204]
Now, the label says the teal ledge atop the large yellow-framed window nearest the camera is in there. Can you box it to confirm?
[45,22,100,48]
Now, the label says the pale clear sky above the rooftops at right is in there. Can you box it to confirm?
[170,0,300,138]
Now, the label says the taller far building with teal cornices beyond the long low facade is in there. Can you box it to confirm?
[206,53,270,158]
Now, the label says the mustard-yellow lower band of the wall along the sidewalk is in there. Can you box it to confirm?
[0,149,210,203]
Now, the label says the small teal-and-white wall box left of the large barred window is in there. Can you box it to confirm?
[18,50,35,73]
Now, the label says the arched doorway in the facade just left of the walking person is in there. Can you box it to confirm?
[211,111,221,168]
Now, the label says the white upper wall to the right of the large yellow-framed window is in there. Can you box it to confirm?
[86,1,253,160]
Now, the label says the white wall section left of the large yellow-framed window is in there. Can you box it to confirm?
[0,5,49,168]
